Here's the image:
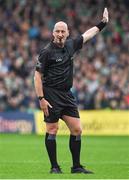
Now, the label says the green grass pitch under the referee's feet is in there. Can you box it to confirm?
[0,134,129,179]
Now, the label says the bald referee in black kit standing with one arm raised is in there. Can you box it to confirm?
[34,8,108,174]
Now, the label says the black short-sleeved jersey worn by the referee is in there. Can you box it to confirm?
[36,36,83,91]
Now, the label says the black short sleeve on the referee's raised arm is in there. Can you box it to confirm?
[73,36,83,52]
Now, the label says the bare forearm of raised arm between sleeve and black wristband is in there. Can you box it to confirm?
[82,26,99,43]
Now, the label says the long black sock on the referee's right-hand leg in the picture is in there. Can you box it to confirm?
[69,135,81,167]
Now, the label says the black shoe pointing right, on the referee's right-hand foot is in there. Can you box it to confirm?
[71,165,94,174]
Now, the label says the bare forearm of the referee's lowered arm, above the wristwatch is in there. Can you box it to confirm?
[34,71,44,97]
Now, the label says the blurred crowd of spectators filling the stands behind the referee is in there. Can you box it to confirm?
[0,0,129,112]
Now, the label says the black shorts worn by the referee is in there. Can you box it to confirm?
[44,87,80,123]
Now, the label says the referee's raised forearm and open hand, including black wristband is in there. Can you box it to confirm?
[82,8,109,43]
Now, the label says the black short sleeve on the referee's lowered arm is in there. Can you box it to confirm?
[36,50,48,74]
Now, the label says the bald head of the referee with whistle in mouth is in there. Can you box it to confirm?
[53,21,69,47]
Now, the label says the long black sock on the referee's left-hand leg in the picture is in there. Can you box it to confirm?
[45,133,58,167]
